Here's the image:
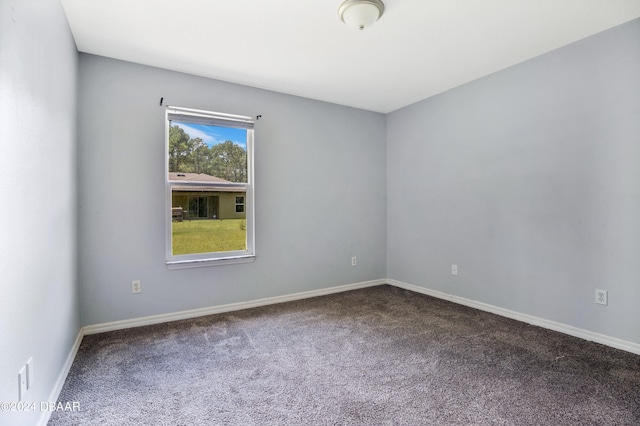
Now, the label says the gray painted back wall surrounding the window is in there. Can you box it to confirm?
[78,54,386,325]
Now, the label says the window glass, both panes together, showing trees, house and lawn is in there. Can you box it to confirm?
[167,121,248,256]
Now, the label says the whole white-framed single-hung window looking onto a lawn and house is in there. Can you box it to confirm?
[165,107,255,268]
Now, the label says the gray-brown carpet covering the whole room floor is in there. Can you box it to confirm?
[49,286,640,426]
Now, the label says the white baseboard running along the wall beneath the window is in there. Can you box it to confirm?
[84,279,387,335]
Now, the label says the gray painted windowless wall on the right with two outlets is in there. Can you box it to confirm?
[387,20,640,343]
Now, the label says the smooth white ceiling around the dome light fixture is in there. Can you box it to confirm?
[61,0,640,113]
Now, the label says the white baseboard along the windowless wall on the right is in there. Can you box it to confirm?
[386,279,640,355]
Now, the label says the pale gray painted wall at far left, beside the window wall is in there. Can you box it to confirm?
[0,0,80,425]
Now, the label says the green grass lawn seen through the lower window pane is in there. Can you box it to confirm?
[171,219,247,255]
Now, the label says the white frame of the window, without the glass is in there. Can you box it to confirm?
[164,106,256,269]
